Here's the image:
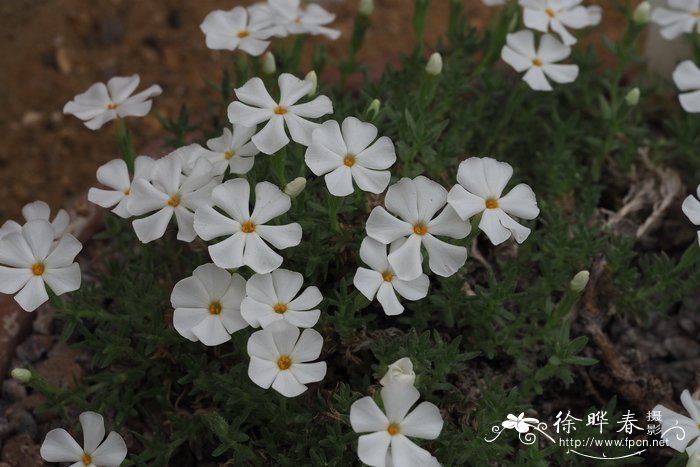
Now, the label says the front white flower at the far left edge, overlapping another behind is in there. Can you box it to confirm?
[0,219,83,311]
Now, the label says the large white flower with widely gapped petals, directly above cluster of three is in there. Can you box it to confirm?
[194,178,302,274]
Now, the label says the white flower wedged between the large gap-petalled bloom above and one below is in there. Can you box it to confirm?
[241,269,323,328]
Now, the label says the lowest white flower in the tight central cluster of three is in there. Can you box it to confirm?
[248,320,326,397]
